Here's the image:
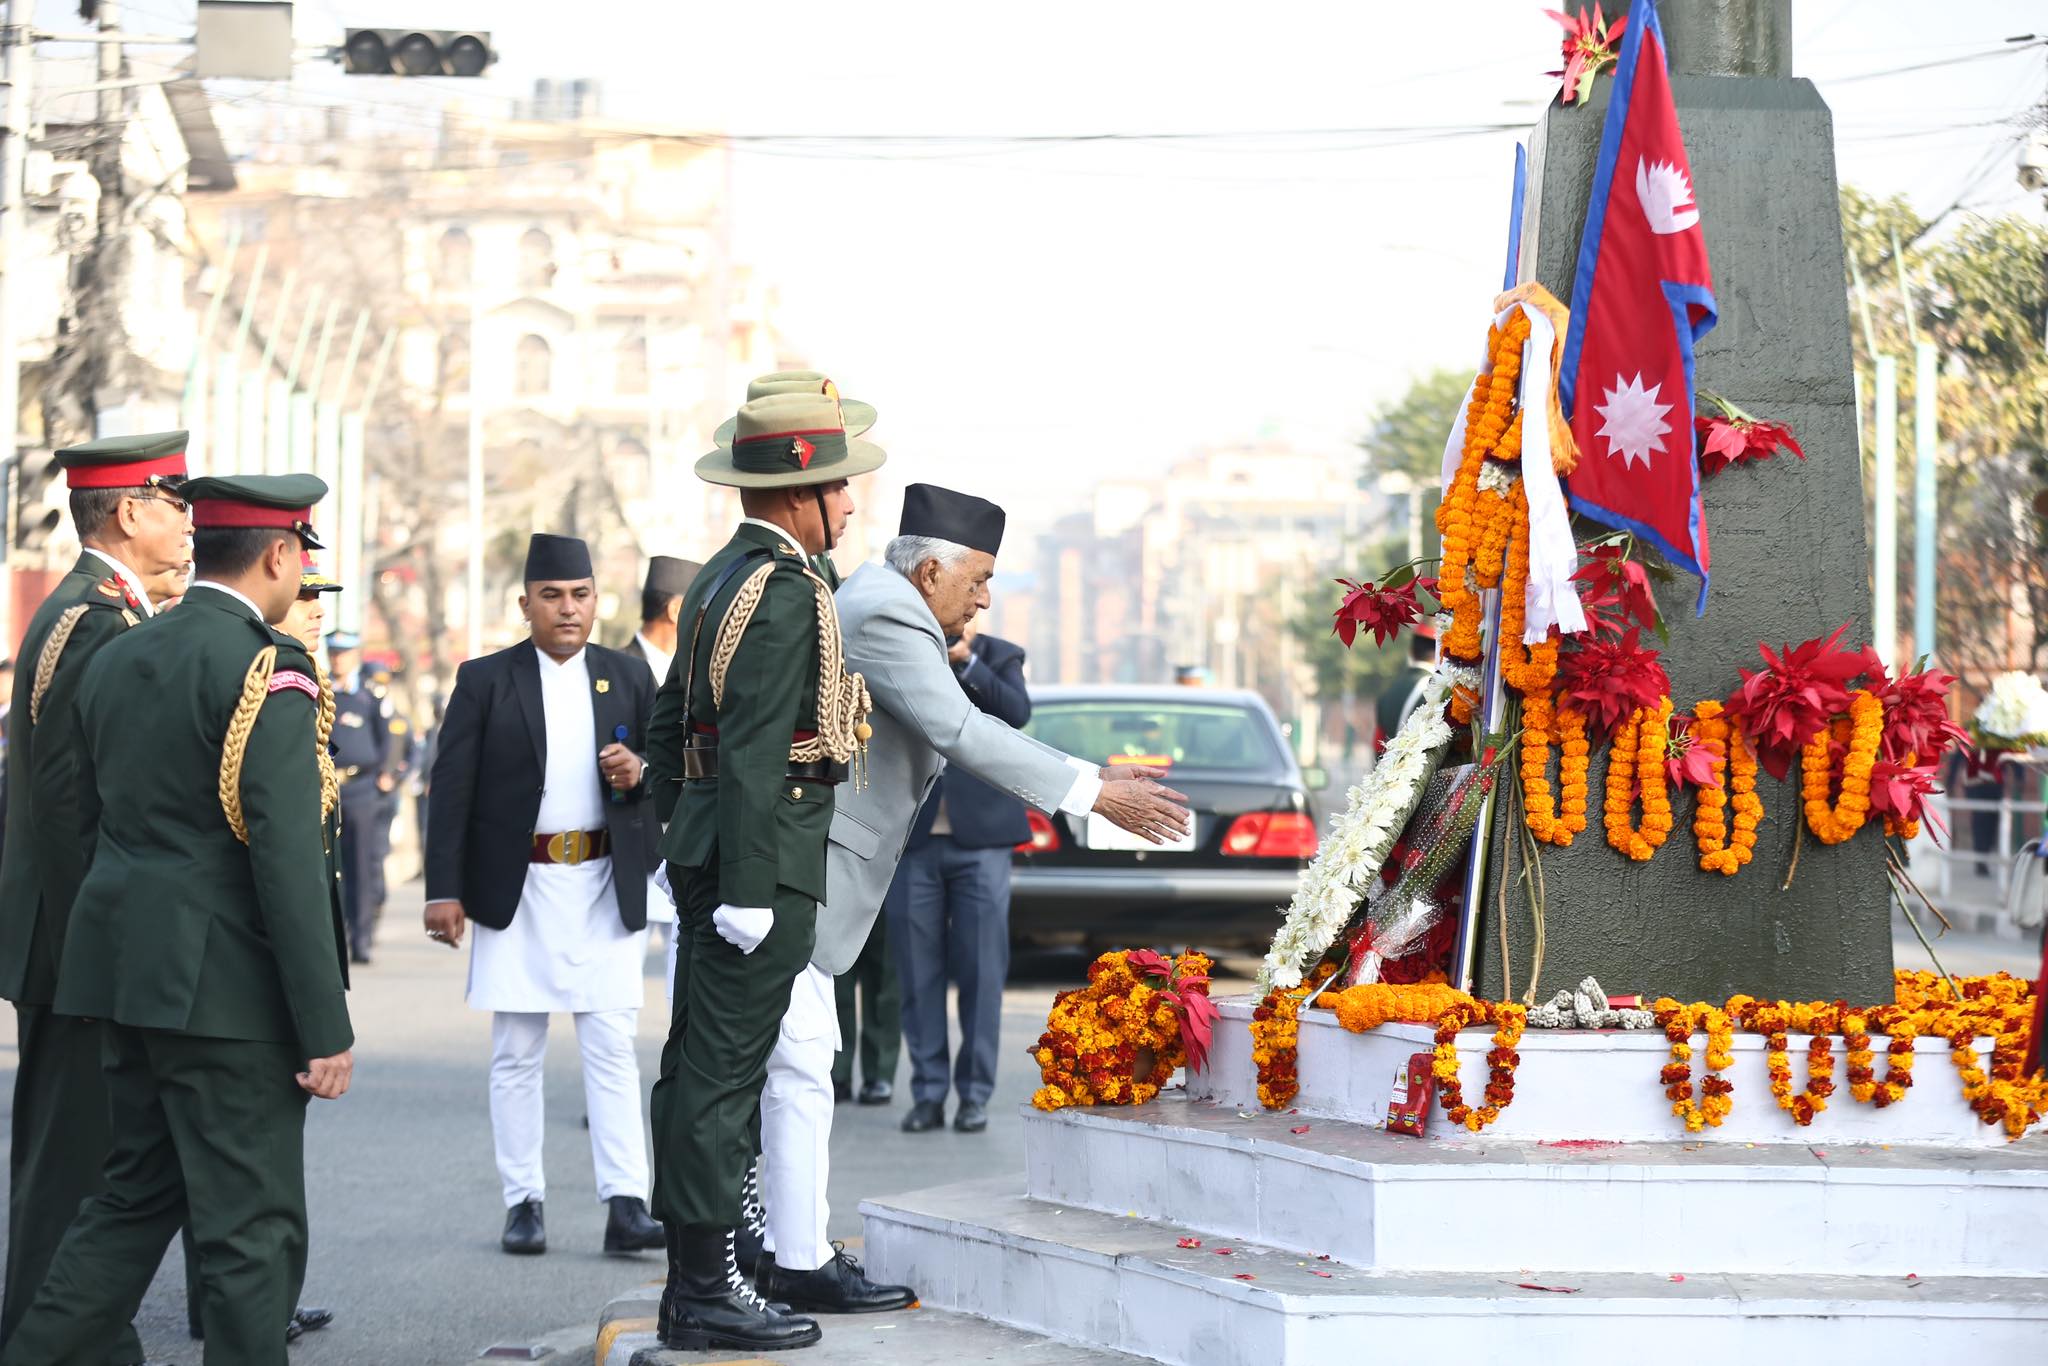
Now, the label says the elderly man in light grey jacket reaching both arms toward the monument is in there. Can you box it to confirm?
[756,483,1188,1313]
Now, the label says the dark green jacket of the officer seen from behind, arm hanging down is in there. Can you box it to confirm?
[57,584,354,1059]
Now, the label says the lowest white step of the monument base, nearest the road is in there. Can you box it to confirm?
[860,1178,2048,1366]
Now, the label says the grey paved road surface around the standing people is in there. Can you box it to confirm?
[0,883,2038,1366]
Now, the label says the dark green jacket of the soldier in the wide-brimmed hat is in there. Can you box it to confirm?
[647,522,831,905]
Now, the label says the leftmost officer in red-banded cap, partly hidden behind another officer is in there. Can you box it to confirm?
[0,432,193,1364]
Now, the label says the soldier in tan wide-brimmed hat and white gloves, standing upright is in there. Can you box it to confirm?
[647,393,885,1350]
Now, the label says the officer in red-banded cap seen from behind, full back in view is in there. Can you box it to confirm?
[0,475,354,1366]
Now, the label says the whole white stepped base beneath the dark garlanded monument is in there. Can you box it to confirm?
[862,1019,2048,1366]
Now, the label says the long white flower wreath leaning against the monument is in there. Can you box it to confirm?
[1257,664,1452,995]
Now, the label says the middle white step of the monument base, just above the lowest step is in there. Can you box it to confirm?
[1024,1092,2048,1276]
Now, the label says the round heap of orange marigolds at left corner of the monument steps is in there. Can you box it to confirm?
[1030,950,1210,1110]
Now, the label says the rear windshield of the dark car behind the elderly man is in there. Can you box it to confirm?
[1026,700,1282,772]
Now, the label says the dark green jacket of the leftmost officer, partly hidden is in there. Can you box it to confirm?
[0,551,145,1006]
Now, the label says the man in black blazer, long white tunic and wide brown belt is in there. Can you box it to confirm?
[426,535,664,1253]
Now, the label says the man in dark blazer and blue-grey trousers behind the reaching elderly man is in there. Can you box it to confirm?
[883,635,1030,1133]
